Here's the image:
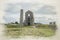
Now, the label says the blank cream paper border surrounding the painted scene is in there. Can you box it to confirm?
[0,0,60,40]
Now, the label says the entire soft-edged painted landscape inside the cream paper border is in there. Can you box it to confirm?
[0,0,57,38]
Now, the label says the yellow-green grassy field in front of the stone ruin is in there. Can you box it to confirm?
[5,25,55,37]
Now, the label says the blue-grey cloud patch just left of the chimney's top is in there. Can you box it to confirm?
[5,4,21,14]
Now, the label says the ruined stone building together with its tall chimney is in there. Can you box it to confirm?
[20,9,34,26]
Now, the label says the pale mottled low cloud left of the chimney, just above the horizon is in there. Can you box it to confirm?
[3,14,20,23]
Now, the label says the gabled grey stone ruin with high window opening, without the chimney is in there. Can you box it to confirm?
[25,10,34,25]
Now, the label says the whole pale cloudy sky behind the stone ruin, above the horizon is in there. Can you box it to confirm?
[0,0,56,23]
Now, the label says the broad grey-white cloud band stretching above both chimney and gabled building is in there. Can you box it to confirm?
[5,3,43,14]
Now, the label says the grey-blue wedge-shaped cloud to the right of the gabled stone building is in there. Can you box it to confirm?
[36,5,56,15]
